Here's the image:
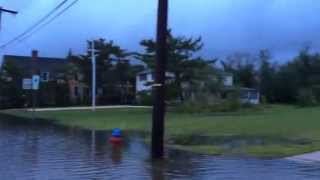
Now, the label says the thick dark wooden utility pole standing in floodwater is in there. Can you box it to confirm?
[152,0,168,159]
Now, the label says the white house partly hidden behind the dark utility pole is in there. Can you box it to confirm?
[136,70,175,92]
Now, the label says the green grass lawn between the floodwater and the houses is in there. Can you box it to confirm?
[2,105,320,157]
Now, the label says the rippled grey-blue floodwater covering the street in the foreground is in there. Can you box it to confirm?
[0,119,320,180]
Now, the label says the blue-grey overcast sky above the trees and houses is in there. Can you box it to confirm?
[0,0,320,62]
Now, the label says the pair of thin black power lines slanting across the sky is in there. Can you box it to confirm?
[0,0,68,48]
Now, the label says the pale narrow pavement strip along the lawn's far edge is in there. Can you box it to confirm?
[27,105,152,112]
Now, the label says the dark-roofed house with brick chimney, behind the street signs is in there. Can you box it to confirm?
[2,50,89,106]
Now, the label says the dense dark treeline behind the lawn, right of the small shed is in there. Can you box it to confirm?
[222,48,320,105]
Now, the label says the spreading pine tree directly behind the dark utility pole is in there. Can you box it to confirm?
[136,32,216,101]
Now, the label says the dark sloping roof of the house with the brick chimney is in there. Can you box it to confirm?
[3,55,69,75]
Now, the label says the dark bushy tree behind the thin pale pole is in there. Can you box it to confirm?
[69,39,143,104]
